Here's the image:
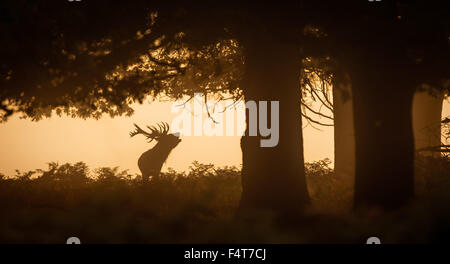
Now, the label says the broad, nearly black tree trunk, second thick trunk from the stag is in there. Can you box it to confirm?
[350,66,414,210]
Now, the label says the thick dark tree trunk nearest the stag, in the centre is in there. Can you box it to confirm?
[239,39,309,219]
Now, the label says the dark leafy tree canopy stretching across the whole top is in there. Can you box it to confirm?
[0,0,449,121]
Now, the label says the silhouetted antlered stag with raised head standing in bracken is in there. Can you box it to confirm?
[130,123,181,182]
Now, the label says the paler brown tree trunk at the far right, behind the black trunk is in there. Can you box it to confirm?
[413,88,444,157]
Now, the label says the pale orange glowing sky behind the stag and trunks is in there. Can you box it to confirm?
[0,98,450,176]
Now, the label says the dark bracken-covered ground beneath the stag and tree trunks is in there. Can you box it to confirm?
[0,157,450,243]
